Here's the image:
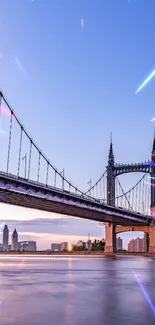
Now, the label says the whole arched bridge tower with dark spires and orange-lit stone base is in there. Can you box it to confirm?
[104,135,155,253]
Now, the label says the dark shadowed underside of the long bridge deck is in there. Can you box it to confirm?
[0,189,146,226]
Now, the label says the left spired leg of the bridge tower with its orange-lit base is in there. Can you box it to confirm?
[104,134,116,254]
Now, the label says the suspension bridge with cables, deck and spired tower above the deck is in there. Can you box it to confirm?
[0,92,155,253]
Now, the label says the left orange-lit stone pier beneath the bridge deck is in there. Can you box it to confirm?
[104,222,116,253]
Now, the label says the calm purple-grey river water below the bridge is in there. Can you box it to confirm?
[0,256,155,325]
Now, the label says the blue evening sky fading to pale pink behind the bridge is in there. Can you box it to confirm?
[0,0,155,248]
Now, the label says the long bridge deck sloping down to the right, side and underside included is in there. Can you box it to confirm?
[0,171,151,226]
